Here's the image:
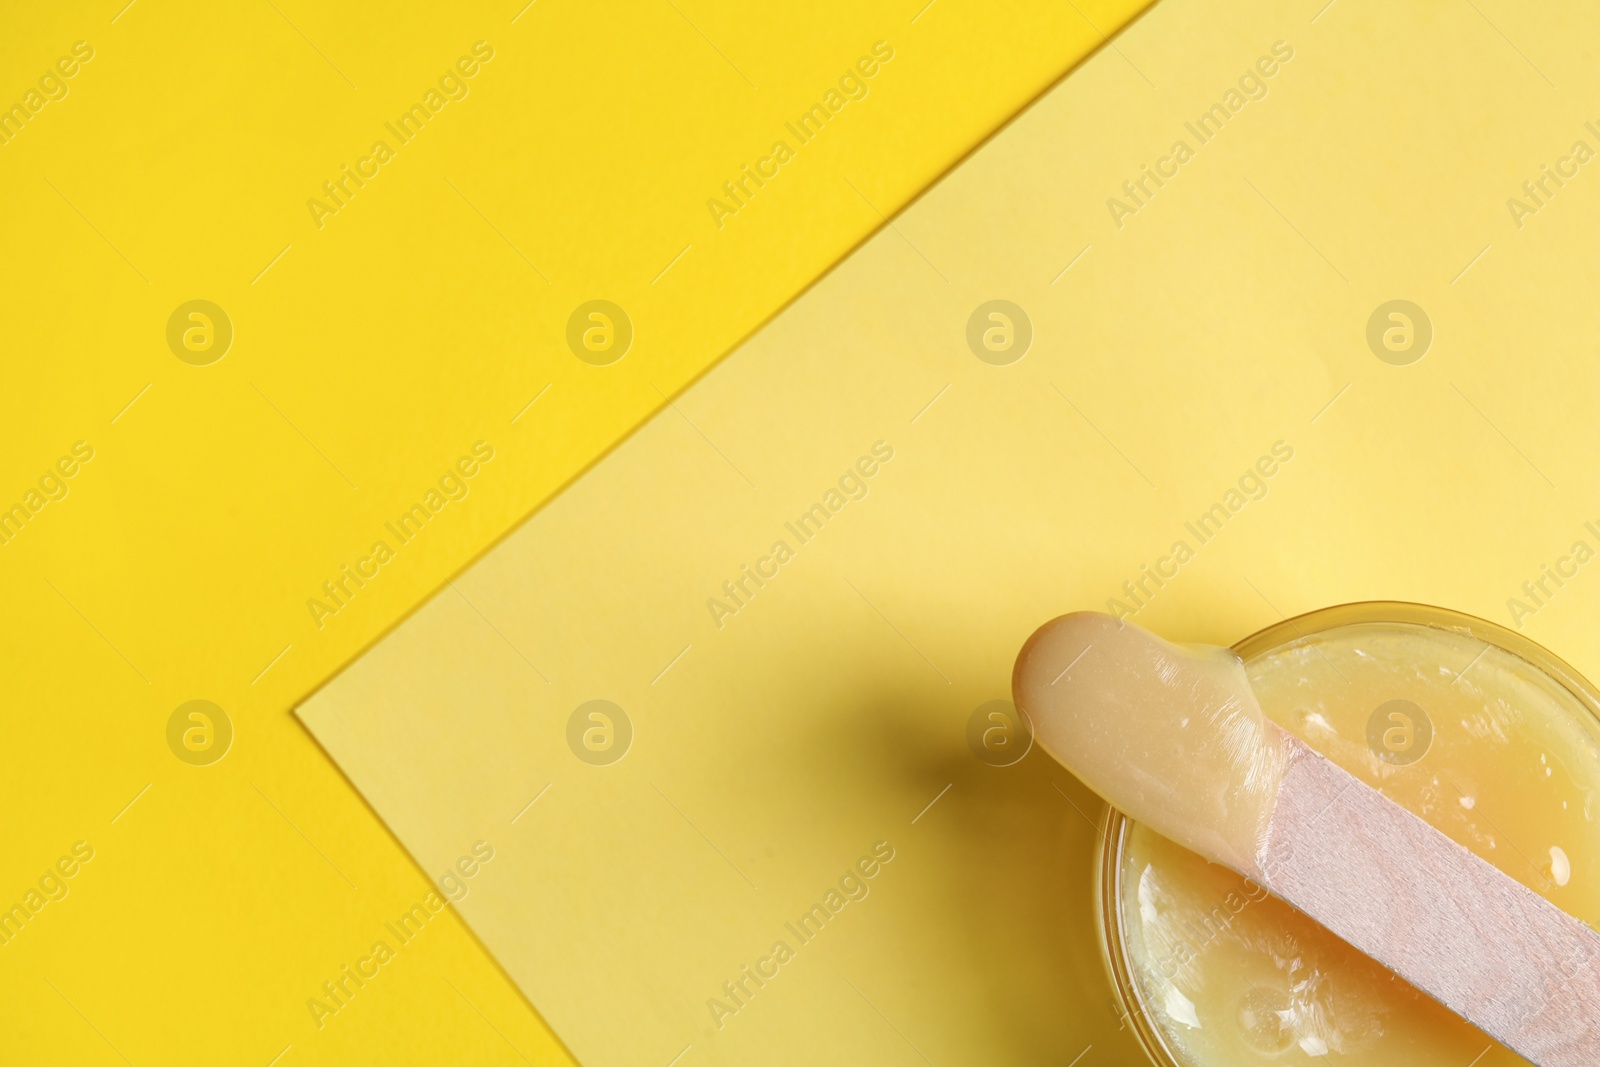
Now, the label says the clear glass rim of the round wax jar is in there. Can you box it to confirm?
[1094,600,1600,1067]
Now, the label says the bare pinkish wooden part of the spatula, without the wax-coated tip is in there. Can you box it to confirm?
[1245,733,1600,1067]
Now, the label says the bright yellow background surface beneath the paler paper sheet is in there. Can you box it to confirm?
[0,0,1152,1064]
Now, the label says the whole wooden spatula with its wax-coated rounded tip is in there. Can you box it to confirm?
[1013,611,1600,1067]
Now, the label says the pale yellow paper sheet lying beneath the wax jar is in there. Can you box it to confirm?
[301,0,1600,1064]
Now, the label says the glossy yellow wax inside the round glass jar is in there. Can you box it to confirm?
[1117,624,1600,1067]
